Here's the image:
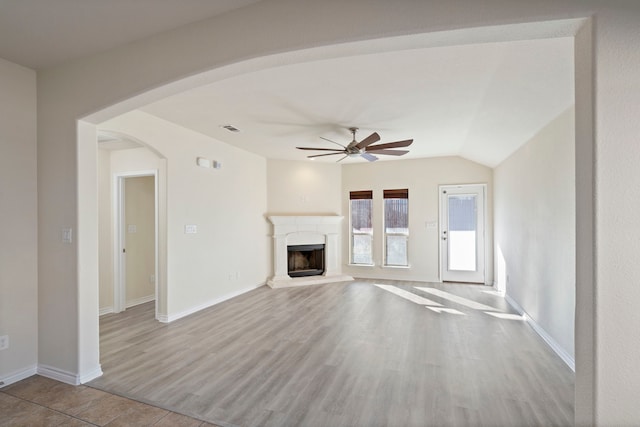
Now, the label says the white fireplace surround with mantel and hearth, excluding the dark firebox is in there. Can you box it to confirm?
[267,215,353,288]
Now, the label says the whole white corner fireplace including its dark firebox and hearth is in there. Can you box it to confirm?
[267,215,353,288]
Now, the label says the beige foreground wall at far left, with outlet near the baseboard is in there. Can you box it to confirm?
[0,59,38,384]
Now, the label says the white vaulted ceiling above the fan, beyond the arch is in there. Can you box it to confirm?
[142,38,574,167]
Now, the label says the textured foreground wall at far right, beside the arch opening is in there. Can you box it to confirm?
[592,8,640,425]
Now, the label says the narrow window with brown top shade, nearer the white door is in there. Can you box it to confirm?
[383,189,409,266]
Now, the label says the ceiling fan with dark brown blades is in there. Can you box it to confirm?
[296,128,413,162]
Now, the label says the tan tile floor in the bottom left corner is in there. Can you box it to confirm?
[0,375,220,427]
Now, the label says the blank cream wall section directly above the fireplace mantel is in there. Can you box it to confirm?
[267,159,342,215]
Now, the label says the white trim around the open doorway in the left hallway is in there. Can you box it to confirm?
[112,169,159,318]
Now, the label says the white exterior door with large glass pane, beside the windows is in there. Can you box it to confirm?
[440,184,486,283]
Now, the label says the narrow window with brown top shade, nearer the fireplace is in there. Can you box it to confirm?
[349,191,373,265]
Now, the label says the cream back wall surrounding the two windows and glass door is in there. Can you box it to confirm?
[342,157,493,283]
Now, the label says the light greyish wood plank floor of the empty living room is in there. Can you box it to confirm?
[88,280,574,427]
